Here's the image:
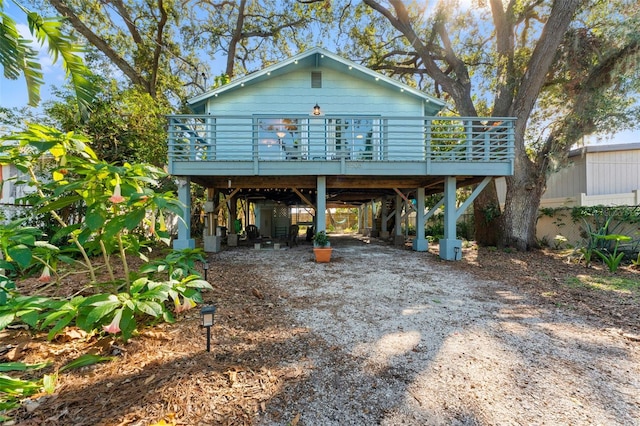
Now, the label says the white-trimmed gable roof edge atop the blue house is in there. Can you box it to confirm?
[187,47,445,112]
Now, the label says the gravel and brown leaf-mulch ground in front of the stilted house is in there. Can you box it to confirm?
[0,236,640,426]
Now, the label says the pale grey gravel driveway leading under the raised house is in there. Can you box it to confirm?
[240,238,640,425]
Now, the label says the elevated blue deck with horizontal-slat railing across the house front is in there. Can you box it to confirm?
[168,114,514,187]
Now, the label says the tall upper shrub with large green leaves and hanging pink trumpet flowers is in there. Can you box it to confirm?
[0,125,182,288]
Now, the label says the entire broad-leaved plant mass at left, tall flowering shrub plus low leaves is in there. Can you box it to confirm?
[0,125,218,341]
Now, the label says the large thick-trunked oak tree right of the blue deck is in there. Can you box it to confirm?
[364,0,640,250]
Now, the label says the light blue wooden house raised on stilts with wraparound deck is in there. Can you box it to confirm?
[169,48,514,260]
